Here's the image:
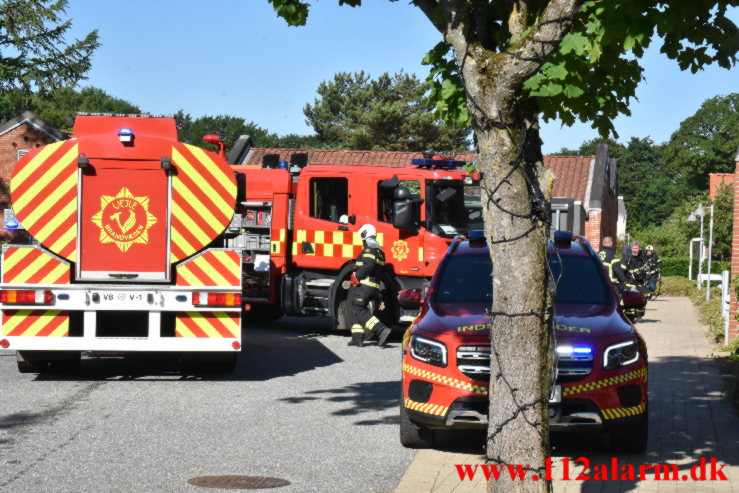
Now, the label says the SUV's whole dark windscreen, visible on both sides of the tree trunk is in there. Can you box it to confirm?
[434,250,612,305]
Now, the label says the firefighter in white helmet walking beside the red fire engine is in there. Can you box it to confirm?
[349,224,390,347]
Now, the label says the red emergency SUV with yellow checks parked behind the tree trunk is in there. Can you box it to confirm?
[400,231,648,451]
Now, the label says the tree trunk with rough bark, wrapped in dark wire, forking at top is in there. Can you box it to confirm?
[422,0,582,492]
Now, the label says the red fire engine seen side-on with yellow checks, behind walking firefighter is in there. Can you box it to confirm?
[227,153,482,330]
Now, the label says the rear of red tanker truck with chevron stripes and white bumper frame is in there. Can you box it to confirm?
[0,114,242,372]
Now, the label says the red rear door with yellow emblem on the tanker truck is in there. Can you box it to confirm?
[77,158,171,282]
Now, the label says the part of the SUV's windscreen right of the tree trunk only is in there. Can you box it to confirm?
[549,254,612,305]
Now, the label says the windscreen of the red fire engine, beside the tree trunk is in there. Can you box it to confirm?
[426,180,483,238]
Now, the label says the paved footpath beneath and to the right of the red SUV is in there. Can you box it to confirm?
[395,297,739,493]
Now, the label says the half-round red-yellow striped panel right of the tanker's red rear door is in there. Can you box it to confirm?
[170,143,236,263]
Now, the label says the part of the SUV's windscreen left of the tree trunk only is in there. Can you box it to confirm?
[434,253,493,303]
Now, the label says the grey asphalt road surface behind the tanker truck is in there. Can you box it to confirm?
[0,318,413,493]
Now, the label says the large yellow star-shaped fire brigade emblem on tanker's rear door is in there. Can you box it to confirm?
[92,187,157,252]
